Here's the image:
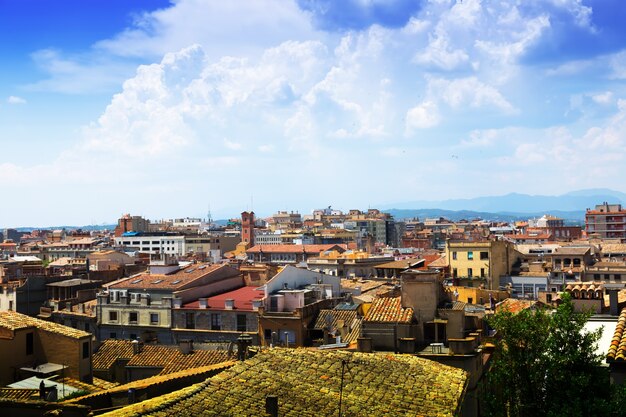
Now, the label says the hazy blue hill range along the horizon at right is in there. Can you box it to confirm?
[379,188,626,219]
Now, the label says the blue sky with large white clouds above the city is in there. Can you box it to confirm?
[0,0,626,227]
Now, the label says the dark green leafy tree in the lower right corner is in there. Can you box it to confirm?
[484,294,612,417]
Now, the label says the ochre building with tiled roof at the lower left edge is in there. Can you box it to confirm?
[0,311,92,386]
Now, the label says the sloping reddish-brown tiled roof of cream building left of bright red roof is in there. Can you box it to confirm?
[109,264,230,291]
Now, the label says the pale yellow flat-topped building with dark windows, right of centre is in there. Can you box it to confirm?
[446,240,517,290]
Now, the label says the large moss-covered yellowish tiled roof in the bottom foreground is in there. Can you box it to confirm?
[100,348,468,417]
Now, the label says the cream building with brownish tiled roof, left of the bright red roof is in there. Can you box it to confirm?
[97,262,243,343]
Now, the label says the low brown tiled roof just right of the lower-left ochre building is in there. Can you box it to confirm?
[92,339,228,375]
